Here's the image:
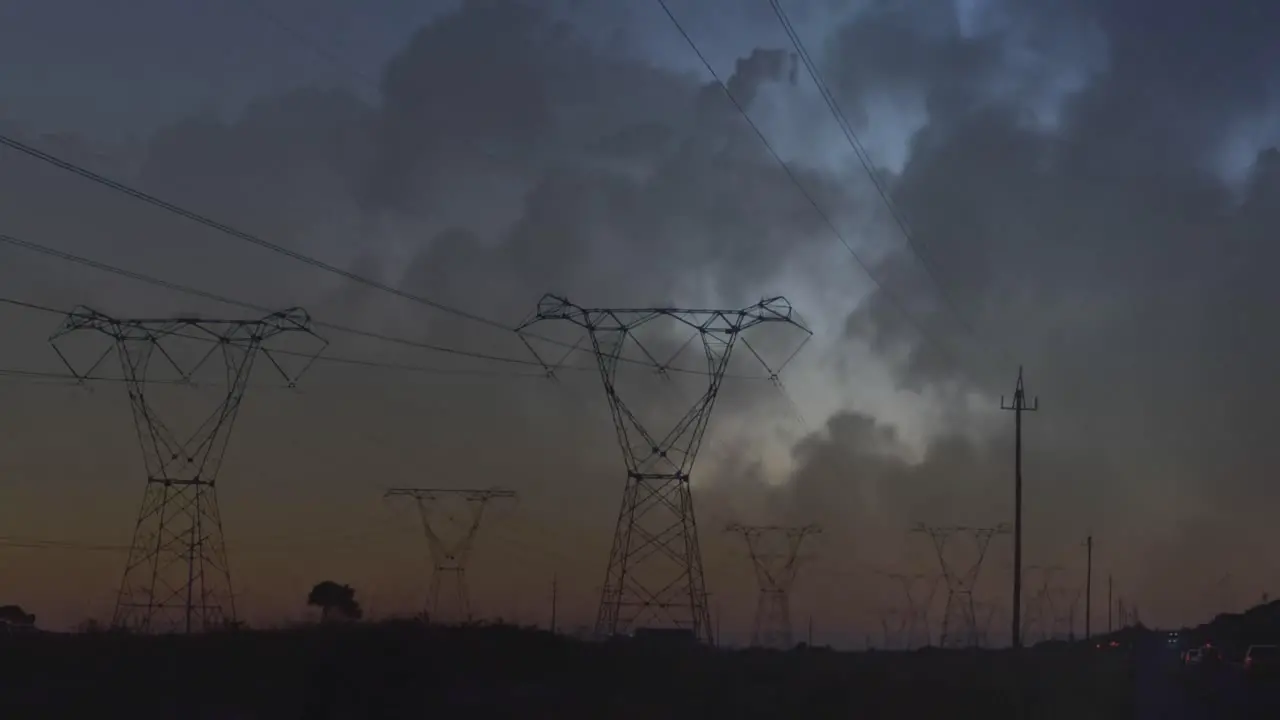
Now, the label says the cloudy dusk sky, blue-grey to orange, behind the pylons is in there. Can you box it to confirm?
[0,0,1280,646]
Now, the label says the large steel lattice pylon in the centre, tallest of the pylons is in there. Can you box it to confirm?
[517,295,809,644]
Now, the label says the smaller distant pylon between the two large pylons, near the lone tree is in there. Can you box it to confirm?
[383,488,516,623]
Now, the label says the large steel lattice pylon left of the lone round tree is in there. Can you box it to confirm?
[50,307,326,633]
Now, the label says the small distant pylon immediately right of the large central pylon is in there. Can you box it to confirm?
[726,524,822,650]
